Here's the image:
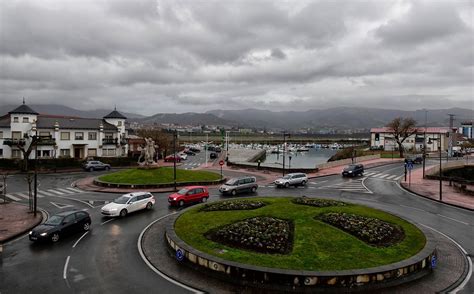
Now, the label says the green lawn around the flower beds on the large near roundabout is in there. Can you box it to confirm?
[175,198,426,271]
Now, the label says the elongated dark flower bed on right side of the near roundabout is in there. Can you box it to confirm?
[319,212,405,247]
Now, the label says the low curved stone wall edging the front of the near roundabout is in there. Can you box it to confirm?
[165,210,437,292]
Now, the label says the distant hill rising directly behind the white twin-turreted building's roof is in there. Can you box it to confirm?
[0,104,145,119]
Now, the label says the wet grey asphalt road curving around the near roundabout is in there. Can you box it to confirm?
[0,163,474,294]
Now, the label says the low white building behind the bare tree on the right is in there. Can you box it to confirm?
[370,127,449,152]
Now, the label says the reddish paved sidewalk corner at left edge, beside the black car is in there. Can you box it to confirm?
[0,202,43,243]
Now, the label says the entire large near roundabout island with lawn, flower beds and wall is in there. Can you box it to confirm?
[165,197,436,291]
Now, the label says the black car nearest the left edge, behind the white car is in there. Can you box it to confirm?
[29,210,91,242]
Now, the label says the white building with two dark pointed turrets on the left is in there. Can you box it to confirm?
[0,102,128,159]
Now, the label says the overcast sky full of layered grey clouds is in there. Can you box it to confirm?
[0,0,474,115]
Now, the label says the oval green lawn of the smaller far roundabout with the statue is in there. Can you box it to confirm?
[99,167,221,185]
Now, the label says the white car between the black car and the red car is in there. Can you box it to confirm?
[100,192,155,217]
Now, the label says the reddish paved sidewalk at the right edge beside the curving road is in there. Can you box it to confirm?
[401,165,474,210]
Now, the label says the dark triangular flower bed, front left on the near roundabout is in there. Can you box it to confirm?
[205,216,293,254]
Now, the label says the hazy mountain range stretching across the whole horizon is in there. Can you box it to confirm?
[0,104,474,130]
